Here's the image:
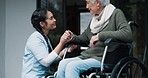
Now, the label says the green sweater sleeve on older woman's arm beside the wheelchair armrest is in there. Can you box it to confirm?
[98,9,132,42]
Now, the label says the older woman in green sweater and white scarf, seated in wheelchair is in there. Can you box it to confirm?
[56,0,132,78]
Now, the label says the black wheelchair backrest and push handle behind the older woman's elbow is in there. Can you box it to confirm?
[105,21,139,65]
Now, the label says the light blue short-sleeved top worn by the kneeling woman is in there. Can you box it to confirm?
[22,31,52,78]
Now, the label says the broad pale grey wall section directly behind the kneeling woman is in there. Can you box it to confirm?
[5,0,36,78]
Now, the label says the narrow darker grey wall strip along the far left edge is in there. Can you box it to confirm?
[0,0,5,78]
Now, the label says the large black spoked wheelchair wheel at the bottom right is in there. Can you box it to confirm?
[111,57,148,78]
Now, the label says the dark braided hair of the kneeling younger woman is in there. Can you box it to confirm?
[31,8,51,52]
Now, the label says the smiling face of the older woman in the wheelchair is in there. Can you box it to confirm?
[86,0,99,14]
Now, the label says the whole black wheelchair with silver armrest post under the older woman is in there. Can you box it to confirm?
[80,21,148,78]
